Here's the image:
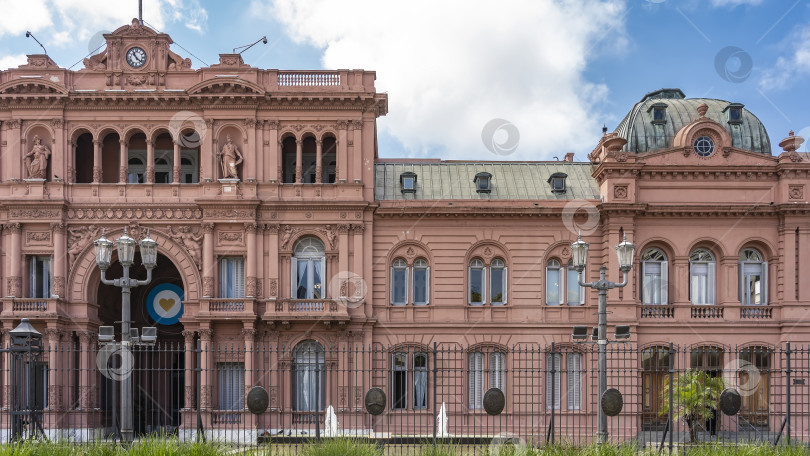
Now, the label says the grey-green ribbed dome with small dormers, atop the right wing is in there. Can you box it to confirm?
[616,89,771,155]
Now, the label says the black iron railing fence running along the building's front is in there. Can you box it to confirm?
[0,337,810,452]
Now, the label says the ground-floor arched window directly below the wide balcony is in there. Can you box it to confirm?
[292,340,326,412]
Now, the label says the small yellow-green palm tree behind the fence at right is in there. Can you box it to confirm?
[661,370,723,443]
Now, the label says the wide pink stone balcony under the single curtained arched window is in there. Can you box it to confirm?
[262,299,351,327]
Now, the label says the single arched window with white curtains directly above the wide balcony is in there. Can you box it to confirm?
[290,237,326,299]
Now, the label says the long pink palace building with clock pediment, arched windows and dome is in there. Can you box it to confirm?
[0,21,810,442]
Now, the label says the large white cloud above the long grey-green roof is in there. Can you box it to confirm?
[262,0,626,160]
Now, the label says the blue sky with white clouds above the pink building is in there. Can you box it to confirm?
[0,0,810,160]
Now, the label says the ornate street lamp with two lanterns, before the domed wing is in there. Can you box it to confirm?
[571,235,636,443]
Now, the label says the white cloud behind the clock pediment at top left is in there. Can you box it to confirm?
[0,0,208,47]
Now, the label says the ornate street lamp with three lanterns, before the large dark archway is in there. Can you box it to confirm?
[93,227,157,442]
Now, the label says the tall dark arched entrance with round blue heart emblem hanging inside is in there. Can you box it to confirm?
[97,253,185,434]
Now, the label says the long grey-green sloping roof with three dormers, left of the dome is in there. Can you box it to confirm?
[374,160,599,200]
